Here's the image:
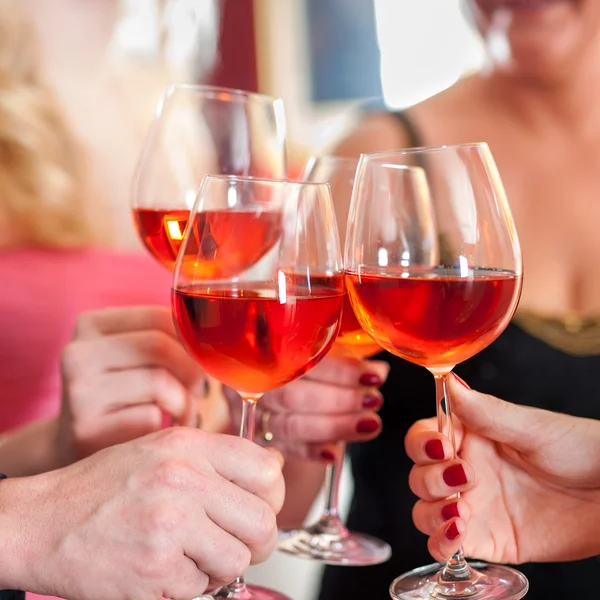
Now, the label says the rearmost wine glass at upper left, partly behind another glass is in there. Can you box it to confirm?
[132,84,286,269]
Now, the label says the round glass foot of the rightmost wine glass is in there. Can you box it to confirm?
[390,562,529,600]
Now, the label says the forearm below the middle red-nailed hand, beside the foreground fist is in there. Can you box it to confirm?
[277,460,325,529]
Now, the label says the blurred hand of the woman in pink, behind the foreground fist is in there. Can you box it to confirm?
[56,306,205,465]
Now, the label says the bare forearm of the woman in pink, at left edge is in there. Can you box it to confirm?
[0,419,61,477]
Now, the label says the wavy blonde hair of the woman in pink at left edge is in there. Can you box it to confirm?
[0,0,93,247]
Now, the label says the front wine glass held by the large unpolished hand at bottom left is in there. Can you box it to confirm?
[172,176,345,600]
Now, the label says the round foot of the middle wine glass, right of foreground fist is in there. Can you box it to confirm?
[278,526,392,567]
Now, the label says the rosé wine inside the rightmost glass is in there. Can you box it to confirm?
[346,269,521,368]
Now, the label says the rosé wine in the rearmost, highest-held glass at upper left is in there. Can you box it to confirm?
[134,209,282,279]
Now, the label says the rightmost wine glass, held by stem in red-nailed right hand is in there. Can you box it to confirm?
[344,143,528,600]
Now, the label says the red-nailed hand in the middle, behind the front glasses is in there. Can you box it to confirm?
[225,354,389,462]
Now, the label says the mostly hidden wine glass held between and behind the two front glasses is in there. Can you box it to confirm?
[279,156,391,566]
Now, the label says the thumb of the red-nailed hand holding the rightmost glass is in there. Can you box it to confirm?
[449,375,565,453]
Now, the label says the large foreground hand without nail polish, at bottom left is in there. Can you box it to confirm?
[0,427,284,600]
